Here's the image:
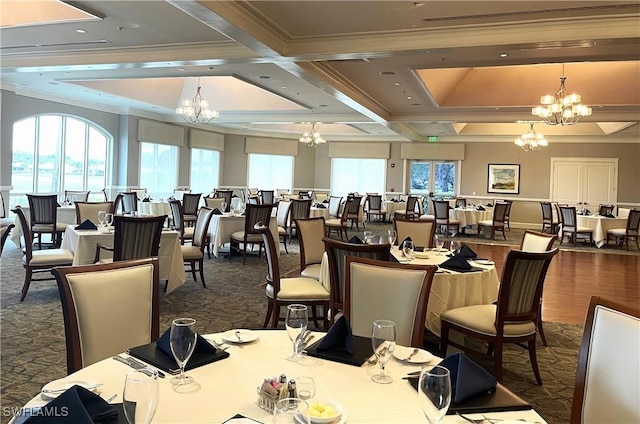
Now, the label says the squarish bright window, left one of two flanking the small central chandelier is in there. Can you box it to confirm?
[247,153,293,191]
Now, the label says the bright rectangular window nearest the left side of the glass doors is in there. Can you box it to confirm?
[331,158,386,197]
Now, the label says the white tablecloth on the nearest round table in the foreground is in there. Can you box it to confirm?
[15,332,545,424]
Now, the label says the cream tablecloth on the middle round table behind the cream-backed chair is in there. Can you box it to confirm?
[319,246,500,336]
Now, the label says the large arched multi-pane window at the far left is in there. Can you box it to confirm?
[9,115,112,207]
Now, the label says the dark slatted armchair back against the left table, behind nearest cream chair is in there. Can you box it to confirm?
[94,215,167,263]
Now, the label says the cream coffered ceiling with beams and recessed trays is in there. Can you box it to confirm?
[0,0,640,143]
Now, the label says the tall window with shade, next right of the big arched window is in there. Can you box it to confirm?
[140,142,178,198]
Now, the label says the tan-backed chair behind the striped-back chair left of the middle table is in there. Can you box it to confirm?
[296,216,326,280]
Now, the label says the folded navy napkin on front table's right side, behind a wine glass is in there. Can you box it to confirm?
[438,353,497,403]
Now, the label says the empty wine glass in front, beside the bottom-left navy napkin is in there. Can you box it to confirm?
[122,368,159,424]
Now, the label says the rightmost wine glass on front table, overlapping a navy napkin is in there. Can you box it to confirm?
[418,365,451,424]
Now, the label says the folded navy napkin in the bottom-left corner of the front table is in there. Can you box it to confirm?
[24,385,118,424]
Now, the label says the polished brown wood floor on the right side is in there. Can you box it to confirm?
[470,244,640,325]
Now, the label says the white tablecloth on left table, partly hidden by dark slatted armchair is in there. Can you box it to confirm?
[61,226,186,294]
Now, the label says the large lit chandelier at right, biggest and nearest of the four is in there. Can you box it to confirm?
[531,65,591,125]
